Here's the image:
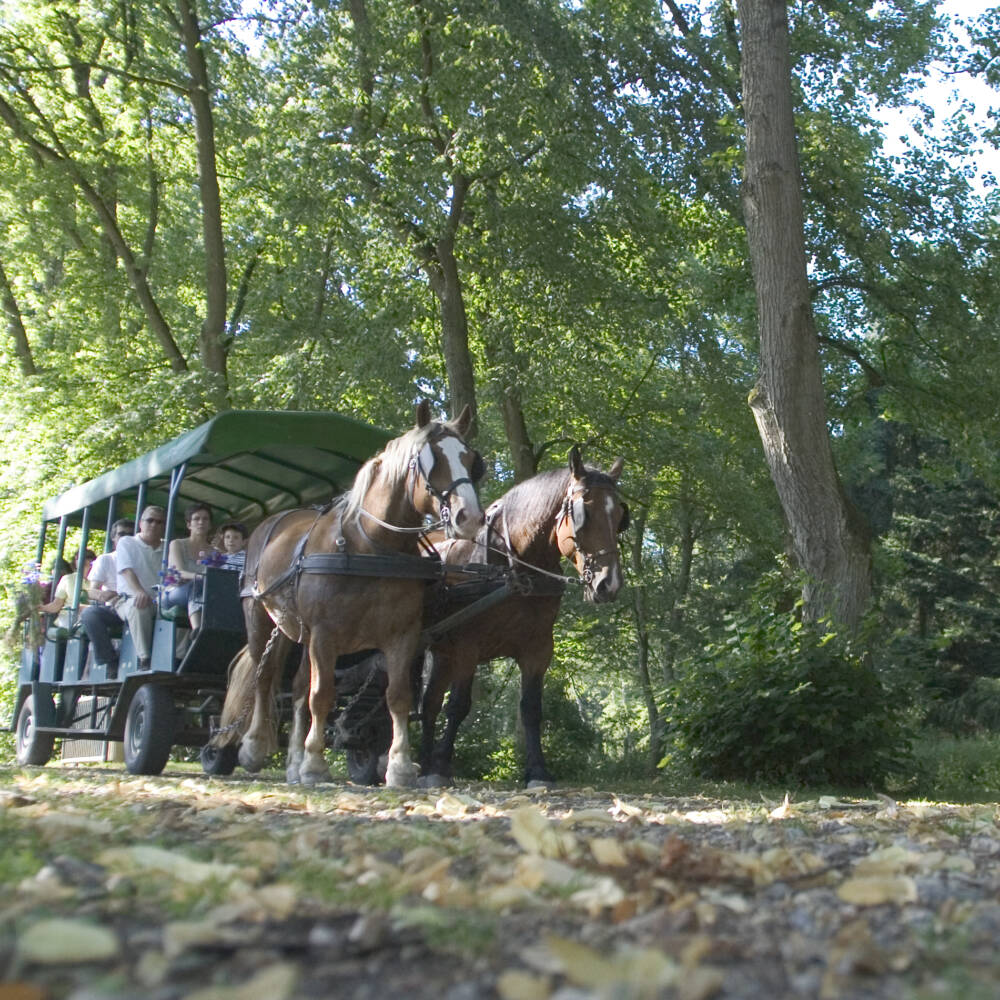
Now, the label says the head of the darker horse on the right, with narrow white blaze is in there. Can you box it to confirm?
[556,445,629,604]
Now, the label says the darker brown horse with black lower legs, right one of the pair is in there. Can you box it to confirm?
[421,447,628,787]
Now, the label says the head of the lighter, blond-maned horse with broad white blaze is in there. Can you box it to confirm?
[411,400,486,538]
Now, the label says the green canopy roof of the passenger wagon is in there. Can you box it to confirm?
[43,410,393,525]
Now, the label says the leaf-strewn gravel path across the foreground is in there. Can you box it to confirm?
[0,767,1000,1000]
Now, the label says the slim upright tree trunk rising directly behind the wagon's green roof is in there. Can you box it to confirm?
[177,0,229,408]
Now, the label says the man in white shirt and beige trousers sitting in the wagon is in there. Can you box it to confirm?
[115,507,167,670]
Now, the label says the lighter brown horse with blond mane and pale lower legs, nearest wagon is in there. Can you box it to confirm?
[212,402,483,785]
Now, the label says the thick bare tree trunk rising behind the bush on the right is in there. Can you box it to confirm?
[738,0,871,627]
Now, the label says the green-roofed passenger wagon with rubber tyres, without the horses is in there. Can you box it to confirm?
[10,411,391,780]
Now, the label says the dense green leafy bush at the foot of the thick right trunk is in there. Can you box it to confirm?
[667,592,910,787]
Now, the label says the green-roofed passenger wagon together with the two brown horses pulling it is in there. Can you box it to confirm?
[14,404,627,784]
